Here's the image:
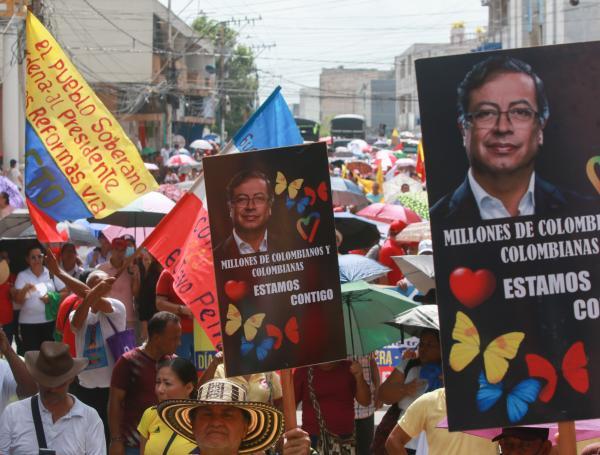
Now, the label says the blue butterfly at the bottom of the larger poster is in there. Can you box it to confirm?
[477,372,542,423]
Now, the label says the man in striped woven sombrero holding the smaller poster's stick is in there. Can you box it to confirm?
[157,379,310,455]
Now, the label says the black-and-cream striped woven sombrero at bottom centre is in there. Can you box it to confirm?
[157,379,283,453]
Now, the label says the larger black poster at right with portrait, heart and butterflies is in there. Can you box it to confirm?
[416,43,600,432]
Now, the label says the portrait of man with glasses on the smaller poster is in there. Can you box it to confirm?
[217,170,274,257]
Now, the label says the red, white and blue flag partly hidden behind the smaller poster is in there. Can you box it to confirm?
[143,87,302,347]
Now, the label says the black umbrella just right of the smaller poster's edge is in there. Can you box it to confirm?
[333,212,380,252]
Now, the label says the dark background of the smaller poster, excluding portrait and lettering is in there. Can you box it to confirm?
[203,143,346,376]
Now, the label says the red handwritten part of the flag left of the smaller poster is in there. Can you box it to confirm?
[143,183,221,346]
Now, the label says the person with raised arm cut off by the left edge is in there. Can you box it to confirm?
[0,328,37,415]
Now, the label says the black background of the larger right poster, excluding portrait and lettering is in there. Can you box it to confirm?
[416,43,600,430]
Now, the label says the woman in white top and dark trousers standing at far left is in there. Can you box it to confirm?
[15,246,65,351]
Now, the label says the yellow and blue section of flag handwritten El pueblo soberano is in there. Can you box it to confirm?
[24,13,158,232]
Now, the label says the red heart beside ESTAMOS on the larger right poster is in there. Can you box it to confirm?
[450,267,496,308]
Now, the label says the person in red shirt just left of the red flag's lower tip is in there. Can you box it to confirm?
[156,270,195,362]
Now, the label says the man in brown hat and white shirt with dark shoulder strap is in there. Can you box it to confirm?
[0,341,106,455]
